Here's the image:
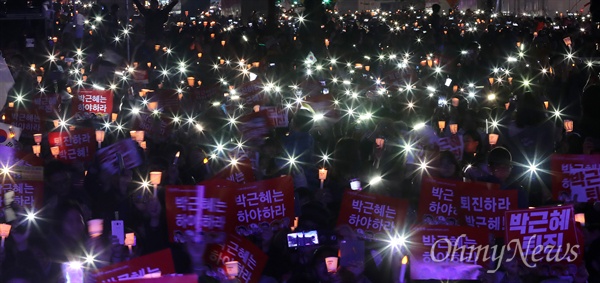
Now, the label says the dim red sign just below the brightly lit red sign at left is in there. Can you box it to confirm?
[48,128,96,162]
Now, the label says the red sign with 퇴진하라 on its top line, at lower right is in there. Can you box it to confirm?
[458,182,519,240]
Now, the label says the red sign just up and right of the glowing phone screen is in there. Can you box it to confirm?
[337,190,408,239]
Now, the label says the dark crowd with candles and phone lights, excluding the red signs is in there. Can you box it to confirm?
[0,0,600,283]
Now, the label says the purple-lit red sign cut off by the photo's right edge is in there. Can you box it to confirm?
[550,154,600,202]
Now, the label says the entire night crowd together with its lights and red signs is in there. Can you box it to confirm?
[0,0,600,283]
